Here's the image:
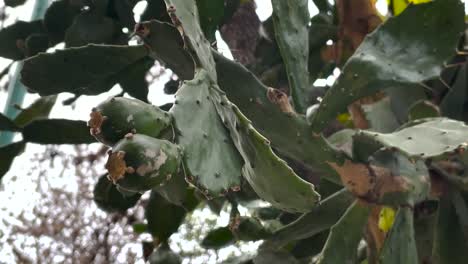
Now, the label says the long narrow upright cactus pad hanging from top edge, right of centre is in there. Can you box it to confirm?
[271,0,310,113]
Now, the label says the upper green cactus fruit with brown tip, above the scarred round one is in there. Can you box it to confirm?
[88,97,171,146]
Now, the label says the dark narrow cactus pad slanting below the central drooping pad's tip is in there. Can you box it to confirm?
[271,189,354,245]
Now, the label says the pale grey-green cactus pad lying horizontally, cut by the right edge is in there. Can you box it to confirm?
[353,118,468,159]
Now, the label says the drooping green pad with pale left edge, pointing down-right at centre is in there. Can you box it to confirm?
[214,89,320,212]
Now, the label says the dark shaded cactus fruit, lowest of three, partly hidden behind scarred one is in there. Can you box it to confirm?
[93,175,141,213]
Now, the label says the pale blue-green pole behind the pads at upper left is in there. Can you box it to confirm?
[0,0,50,146]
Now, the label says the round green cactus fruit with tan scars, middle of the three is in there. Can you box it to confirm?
[106,133,181,192]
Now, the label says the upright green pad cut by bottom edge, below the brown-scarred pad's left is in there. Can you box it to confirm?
[318,201,370,264]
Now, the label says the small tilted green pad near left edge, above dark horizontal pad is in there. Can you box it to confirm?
[13,95,57,127]
